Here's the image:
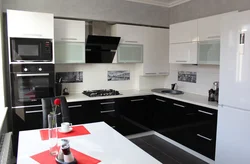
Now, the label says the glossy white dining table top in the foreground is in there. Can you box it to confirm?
[17,122,160,164]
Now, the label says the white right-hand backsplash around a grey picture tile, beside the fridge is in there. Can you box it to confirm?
[165,64,219,96]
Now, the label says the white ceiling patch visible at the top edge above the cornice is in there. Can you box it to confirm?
[127,0,191,7]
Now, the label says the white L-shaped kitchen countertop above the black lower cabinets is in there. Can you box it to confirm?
[66,89,218,110]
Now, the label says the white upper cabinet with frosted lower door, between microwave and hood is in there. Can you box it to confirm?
[55,19,85,64]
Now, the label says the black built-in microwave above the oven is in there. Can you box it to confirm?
[10,38,53,62]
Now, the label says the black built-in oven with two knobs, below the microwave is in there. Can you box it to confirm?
[11,64,55,108]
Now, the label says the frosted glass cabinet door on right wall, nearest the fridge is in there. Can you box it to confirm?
[198,40,220,65]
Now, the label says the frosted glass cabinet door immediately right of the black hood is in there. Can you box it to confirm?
[117,44,143,63]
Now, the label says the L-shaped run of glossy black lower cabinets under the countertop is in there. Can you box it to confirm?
[68,95,217,159]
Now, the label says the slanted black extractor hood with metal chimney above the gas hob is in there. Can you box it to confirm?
[85,22,121,63]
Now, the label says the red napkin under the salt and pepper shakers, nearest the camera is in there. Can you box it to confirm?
[31,148,101,164]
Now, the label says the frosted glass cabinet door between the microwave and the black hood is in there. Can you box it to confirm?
[55,42,85,63]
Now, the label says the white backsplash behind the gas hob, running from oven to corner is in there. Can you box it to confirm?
[55,64,166,93]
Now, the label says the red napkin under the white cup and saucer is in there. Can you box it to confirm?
[40,125,90,140]
